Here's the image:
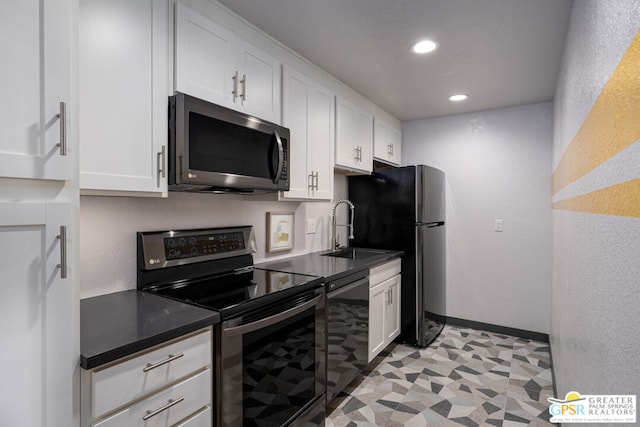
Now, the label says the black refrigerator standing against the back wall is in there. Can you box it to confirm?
[348,165,446,347]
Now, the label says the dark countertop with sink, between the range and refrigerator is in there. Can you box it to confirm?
[255,247,404,281]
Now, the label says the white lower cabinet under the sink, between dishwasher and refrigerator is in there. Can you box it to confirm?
[368,259,401,362]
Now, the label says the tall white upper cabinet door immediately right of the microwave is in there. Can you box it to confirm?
[282,67,311,199]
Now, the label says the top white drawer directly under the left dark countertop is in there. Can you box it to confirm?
[90,330,212,418]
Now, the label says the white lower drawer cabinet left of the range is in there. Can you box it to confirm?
[81,328,213,427]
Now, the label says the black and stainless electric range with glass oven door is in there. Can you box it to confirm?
[137,226,326,427]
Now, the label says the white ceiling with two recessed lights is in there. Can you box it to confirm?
[218,0,571,120]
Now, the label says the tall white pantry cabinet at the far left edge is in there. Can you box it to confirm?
[0,0,79,427]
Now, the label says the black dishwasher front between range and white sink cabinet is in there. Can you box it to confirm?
[326,269,369,402]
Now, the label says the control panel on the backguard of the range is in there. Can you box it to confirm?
[138,226,256,270]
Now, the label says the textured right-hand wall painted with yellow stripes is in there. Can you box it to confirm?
[551,0,640,396]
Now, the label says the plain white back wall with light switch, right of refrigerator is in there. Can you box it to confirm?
[402,103,552,333]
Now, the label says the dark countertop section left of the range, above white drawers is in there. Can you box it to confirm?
[80,290,220,369]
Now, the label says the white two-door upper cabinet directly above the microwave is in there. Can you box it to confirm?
[175,3,282,124]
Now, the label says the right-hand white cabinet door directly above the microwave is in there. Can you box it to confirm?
[236,39,282,124]
